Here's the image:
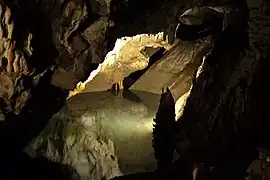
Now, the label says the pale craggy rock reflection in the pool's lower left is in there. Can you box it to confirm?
[25,95,122,180]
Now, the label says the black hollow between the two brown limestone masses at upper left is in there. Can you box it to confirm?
[7,1,58,74]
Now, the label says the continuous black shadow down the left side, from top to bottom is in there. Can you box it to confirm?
[0,1,78,179]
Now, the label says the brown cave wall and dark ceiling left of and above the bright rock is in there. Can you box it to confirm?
[0,0,234,119]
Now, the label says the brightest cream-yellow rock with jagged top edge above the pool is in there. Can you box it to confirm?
[71,33,170,96]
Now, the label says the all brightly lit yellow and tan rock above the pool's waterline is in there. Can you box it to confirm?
[70,36,211,123]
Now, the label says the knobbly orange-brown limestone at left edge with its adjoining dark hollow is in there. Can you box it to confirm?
[0,1,54,114]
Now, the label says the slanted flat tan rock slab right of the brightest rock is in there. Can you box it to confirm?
[131,39,211,100]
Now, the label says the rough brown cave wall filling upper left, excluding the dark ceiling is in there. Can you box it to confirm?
[0,0,110,116]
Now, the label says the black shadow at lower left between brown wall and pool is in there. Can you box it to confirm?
[0,74,76,180]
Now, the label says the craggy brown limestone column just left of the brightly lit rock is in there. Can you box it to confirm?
[49,0,113,90]
